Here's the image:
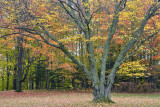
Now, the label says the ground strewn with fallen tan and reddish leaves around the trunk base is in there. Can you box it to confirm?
[0,90,160,107]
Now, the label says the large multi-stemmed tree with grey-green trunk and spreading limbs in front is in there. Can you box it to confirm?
[1,0,160,103]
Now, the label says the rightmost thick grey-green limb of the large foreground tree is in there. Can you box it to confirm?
[104,3,159,89]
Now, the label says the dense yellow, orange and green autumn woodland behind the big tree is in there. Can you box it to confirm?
[0,0,160,92]
